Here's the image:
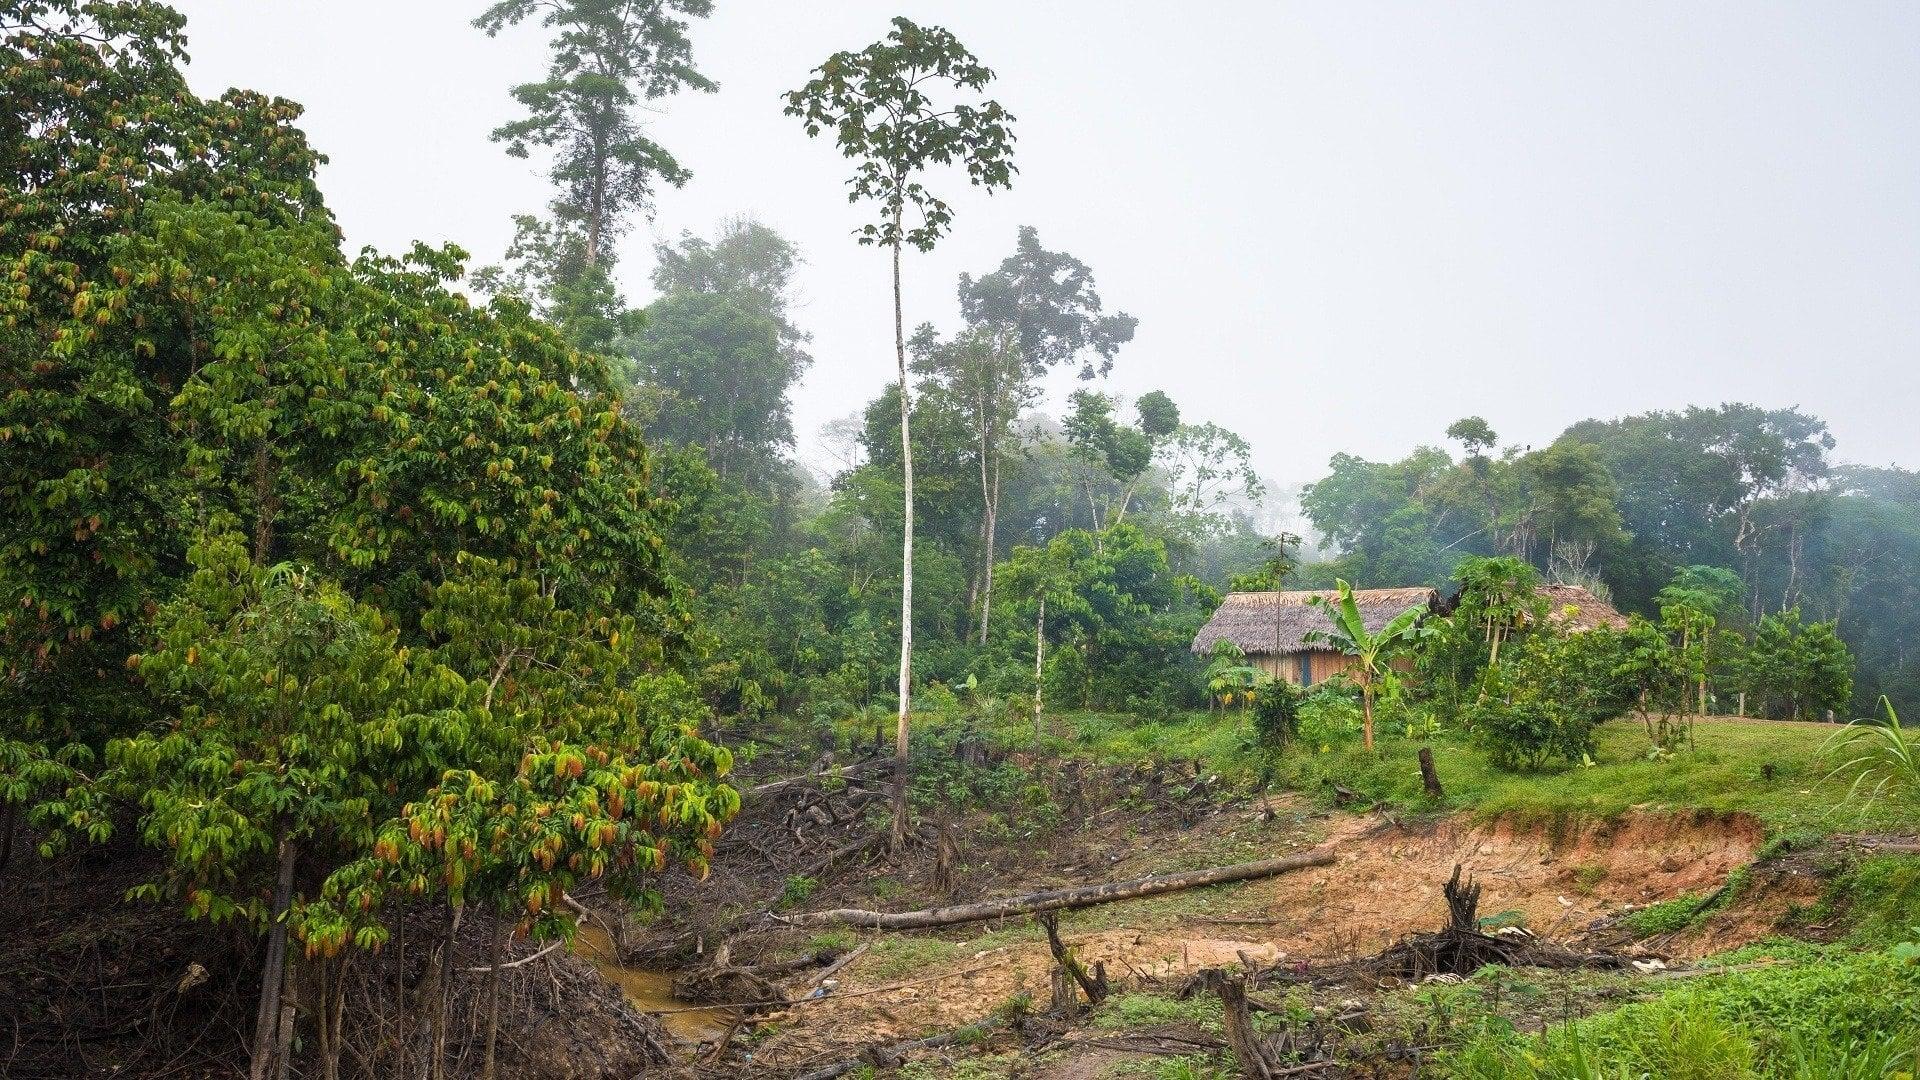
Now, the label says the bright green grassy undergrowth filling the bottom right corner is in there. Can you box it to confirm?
[1444,945,1920,1080]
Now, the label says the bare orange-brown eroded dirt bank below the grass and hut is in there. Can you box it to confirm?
[633,799,1764,1068]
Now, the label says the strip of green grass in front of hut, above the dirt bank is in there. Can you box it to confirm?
[1066,713,1920,836]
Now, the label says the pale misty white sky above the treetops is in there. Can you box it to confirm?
[175,0,1920,482]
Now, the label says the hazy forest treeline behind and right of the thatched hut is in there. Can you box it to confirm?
[1302,405,1920,719]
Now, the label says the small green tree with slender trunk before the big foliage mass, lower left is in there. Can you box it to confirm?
[94,532,474,1078]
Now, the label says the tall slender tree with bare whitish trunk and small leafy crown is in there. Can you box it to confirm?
[787,17,1016,847]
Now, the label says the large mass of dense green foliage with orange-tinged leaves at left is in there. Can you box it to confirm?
[0,2,737,1068]
